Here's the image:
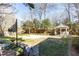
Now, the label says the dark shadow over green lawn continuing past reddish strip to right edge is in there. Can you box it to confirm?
[38,37,79,56]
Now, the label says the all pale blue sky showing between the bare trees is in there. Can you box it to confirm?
[13,3,78,24]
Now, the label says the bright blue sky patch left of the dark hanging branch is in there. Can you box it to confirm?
[13,3,29,22]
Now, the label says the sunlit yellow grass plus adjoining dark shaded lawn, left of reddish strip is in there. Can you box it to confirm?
[18,35,68,56]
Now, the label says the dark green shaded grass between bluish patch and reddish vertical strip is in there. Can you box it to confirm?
[39,39,67,56]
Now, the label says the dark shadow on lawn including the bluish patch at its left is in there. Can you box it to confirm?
[26,38,68,56]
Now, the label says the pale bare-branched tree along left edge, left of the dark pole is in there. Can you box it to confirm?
[0,3,13,35]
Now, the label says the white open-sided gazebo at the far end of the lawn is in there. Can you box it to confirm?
[54,24,69,35]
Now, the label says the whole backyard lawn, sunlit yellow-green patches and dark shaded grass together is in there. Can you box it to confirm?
[0,34,79,56]
